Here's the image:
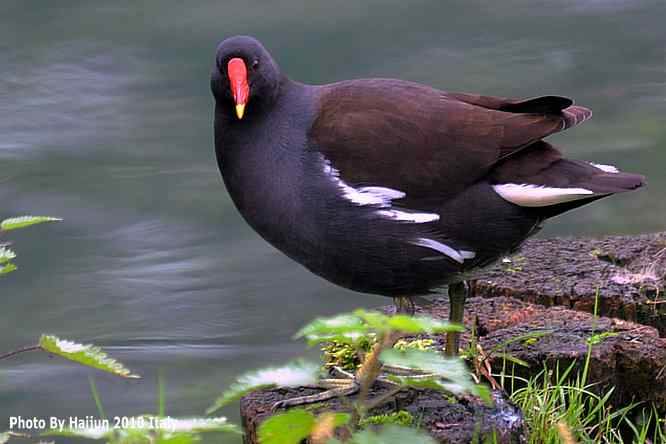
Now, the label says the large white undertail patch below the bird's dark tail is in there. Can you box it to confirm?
[493,183,594,207]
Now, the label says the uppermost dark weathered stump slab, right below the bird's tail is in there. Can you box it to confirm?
[472,232,666,336]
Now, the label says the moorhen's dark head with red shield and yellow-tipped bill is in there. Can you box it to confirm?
[210,36,281,120]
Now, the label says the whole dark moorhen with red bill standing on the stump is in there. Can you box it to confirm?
[211,36,644,354]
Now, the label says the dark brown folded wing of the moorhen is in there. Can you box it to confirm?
[309,79,589,198]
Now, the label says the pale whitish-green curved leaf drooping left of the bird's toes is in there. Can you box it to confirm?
[206,361,320,414]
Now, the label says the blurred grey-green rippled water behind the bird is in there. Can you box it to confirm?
[0,0,666,442]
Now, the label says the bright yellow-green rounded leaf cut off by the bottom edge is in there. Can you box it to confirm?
[258,409,315,444]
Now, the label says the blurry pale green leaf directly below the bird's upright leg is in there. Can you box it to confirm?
[379,349,479,396]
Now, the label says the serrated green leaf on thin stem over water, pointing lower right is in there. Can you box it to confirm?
[39,335,140,378]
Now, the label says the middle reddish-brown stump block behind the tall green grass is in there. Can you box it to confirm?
[408,297,666,409]
